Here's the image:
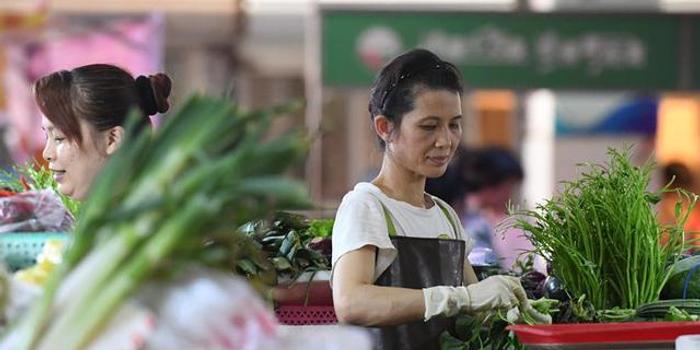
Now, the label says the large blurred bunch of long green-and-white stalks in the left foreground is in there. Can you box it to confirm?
[0,98,308,350]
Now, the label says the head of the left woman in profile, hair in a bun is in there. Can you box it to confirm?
[34,64,172,200]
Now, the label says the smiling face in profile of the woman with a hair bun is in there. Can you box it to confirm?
[41,117,108,200]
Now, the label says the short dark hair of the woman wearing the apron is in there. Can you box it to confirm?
[369,49,464,147]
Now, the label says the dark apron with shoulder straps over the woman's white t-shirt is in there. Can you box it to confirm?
[371,200,465,350]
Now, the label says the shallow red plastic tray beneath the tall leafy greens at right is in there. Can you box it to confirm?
[508,322,700,349]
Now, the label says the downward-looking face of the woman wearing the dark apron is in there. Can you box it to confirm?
[387,89,462,177]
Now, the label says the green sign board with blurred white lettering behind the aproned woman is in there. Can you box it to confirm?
[322,10,700,90]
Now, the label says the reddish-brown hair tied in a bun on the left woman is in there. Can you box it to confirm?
[34,64,172,144]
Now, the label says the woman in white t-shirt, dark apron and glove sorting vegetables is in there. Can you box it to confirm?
[332,49,529,350]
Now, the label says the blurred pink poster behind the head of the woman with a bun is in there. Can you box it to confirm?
[0,15,164,162]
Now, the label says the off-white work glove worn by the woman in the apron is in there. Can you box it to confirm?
[423,276,529,321]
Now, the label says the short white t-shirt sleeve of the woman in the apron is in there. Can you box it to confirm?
[331,190,396,281]
